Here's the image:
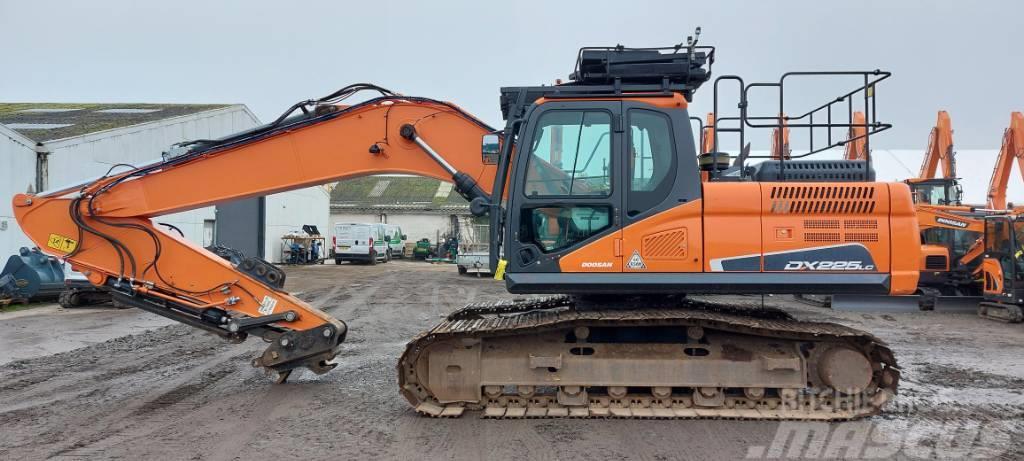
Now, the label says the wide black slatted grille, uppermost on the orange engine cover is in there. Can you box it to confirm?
[770,185,876,214]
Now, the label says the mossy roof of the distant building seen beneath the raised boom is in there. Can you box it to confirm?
[331,175,469,209]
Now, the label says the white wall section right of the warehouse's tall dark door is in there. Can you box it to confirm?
[264,185,331,262]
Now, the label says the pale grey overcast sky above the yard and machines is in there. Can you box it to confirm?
[0,0,1024,154]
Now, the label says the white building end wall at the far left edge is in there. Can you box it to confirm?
[0,127,36,259]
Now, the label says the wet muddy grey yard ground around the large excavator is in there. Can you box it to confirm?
[0,261,1024,460]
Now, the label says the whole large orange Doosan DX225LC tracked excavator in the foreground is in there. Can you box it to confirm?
[13,37,920,420]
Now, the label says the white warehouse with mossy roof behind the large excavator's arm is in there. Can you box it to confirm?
[0,103,330,262]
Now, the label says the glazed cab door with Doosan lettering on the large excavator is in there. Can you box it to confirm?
[506,100,623,273]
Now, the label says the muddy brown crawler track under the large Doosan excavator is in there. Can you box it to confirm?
[398,296,899,420]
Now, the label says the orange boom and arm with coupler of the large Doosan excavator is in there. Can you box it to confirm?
[13,85,496,380]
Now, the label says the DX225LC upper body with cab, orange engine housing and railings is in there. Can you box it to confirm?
[489,45,916,295]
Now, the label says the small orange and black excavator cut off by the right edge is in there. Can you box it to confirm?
[978,215,1024,323]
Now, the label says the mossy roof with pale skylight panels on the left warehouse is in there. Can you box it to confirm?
[0,102,229,142]
